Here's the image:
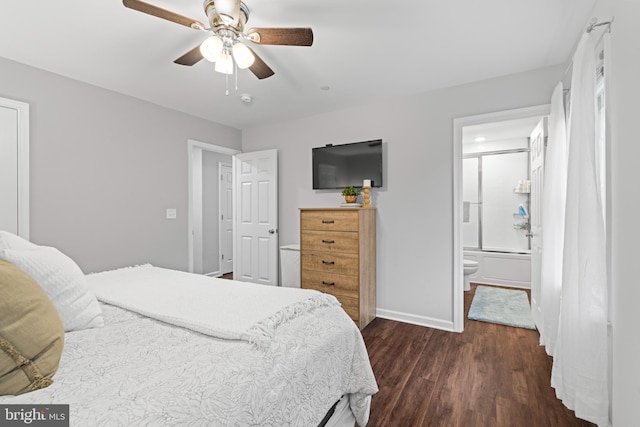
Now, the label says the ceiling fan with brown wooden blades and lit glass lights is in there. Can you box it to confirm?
[122,0,313,79]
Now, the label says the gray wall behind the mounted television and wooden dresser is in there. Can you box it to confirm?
[242,67,564,328]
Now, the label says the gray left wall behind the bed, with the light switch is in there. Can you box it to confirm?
[0,58,241,272]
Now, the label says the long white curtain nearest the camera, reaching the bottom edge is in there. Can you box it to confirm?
[551,31,609,426]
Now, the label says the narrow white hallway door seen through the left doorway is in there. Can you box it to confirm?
[219,163,233,274]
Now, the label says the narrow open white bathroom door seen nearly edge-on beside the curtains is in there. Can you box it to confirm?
[528,117,547,325]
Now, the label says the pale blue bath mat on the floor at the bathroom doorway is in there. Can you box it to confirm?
[467,285,536,329]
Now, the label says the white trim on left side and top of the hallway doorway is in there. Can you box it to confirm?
[187,139,242,273]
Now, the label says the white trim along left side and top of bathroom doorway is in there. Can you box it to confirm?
[452,104,551,332]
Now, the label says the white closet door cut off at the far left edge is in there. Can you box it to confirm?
[0,98,29,239]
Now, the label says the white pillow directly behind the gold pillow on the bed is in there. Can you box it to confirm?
[0,246,104,332]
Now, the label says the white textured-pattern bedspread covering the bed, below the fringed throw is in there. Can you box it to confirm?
[0,266,378,427]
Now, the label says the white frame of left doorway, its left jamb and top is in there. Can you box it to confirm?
[187,139,242,273]
